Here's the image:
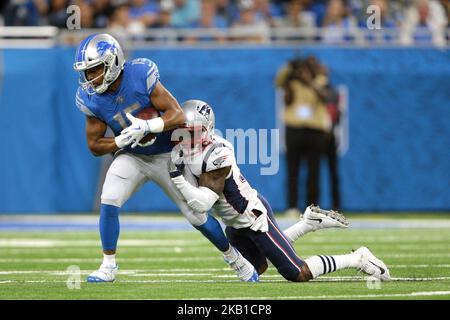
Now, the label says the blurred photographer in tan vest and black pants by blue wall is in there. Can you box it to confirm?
[275,59,331,216]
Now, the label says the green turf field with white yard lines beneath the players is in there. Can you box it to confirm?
[0,216,450,300]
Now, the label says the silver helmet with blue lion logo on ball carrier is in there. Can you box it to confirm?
[73,33,125,95]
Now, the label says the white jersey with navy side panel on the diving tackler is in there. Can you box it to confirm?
[186,135,267,229]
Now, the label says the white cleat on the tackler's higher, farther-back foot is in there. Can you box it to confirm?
[303,205,349,231]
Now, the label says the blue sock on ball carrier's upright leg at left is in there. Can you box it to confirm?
[99,204,120,250]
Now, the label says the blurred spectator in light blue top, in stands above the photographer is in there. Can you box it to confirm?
[322,0,356,44]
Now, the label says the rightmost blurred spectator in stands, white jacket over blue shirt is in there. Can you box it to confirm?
[400,0,448,46]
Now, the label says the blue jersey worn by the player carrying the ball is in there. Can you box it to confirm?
[75,58,174,154]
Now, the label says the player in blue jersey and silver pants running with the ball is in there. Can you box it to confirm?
[74,34,258,282]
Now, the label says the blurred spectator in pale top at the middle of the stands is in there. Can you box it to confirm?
[230,0,270,43]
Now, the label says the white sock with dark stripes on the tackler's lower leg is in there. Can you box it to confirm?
[305,253,361,278]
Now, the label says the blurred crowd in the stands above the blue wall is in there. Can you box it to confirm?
[0,0,450,45]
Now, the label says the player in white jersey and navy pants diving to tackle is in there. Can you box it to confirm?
[169,100,390,282]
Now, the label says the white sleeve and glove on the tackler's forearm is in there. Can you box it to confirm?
[172,175,219,212]
